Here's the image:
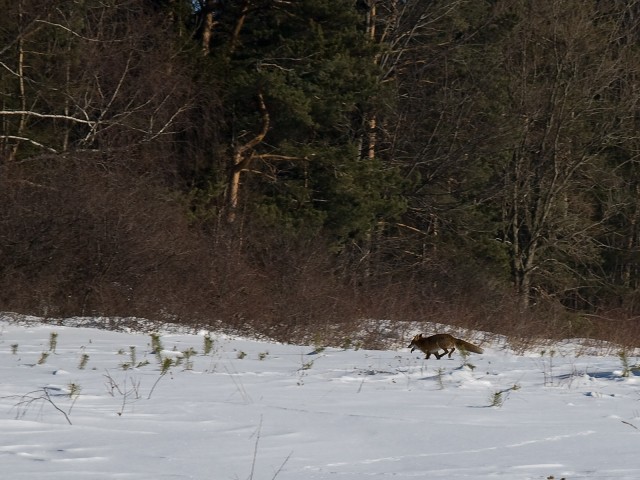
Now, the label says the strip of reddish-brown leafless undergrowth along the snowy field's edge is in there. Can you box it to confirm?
[0,158,640,348]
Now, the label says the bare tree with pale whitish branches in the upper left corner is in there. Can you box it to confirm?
[0,0,190,160]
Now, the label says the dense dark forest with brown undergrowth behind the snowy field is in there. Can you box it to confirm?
[0,0,640,346]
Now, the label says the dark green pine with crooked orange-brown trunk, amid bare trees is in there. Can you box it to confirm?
[192,0,401,246]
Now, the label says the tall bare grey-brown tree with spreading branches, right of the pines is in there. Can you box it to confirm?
[503,1,637,306]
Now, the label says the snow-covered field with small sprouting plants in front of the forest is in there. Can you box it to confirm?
[0,315,640,480]
